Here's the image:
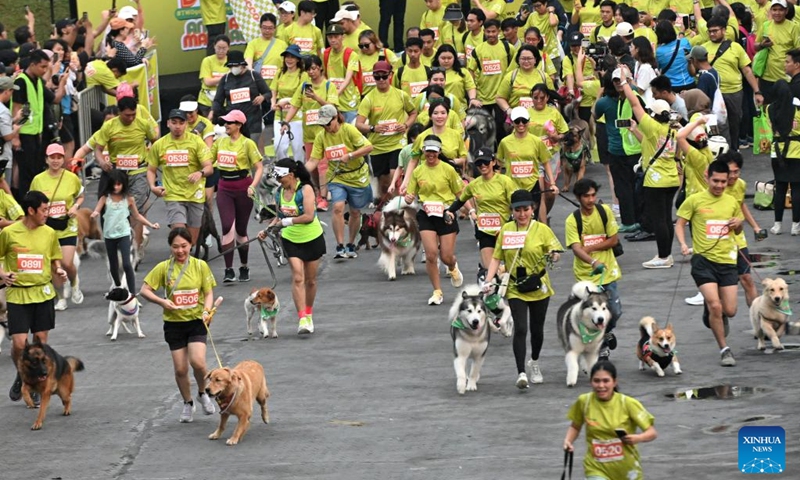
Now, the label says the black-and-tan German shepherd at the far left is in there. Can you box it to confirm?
[17,341,83,430]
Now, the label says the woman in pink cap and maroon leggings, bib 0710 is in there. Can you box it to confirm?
[211,110,264,283]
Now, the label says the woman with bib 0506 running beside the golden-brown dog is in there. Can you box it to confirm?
[141,227,217,423]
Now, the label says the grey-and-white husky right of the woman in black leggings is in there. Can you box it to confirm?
[556,281,611,387]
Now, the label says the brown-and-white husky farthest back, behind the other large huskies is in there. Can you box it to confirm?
[378,207,422,280]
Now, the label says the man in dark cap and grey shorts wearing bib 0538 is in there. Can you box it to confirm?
[147,109,214,242]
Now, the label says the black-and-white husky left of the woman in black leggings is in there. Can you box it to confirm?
[448,285,491,395]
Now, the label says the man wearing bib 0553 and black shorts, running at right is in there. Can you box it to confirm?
[675,160,742,367]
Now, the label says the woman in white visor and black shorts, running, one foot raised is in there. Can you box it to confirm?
[405,135,464,305]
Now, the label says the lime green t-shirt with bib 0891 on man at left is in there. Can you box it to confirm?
[0,221,61,304]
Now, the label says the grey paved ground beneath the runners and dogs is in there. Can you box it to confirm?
[0,152,800,479]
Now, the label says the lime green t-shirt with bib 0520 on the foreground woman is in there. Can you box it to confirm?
[567,392,655,480]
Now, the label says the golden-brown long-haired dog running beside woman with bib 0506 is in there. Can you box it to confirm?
[206,360,269,445]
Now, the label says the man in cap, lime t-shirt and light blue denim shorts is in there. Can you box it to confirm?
[306,105,374,259]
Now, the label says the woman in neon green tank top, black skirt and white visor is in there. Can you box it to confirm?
[258,158,326,334]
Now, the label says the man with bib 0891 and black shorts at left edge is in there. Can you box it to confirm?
[0,190,67,406]
